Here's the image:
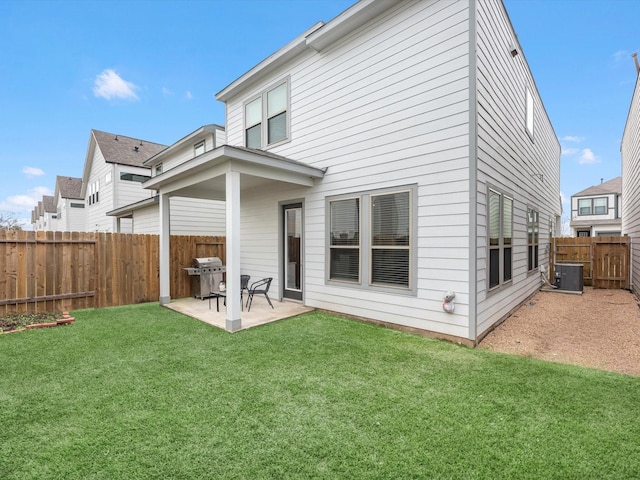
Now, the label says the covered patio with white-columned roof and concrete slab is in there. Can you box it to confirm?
[144,145,325,332]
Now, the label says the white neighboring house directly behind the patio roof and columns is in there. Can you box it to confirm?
[107,125,225,235]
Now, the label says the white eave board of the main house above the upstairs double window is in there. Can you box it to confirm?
[216,22,324,102]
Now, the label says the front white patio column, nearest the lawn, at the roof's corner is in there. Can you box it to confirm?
[225,172,242,332]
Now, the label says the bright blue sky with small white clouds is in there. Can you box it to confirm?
[0,0,640,229]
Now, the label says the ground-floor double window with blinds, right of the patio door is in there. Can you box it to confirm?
[328,189,413,289]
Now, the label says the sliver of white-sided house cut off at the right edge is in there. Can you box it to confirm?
[620,66,640,296]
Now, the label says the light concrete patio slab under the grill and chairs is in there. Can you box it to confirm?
[165,296,313,330]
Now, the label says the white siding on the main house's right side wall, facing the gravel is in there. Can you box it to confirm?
[475,0,560,335]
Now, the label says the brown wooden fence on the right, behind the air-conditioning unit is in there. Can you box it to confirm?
[549,237,631,289]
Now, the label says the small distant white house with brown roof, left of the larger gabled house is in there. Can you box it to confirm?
[50,175,85,232]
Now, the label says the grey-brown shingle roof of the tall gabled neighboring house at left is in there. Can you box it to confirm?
[91,130,167,168]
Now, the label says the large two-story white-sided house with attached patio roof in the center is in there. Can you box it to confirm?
[144,0,561,344]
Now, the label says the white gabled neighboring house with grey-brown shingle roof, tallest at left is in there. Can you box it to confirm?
[82,130,166,233]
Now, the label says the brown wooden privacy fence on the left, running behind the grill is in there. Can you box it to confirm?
[0,231,226,314]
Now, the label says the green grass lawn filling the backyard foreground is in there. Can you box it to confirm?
[0,304,640,480]
